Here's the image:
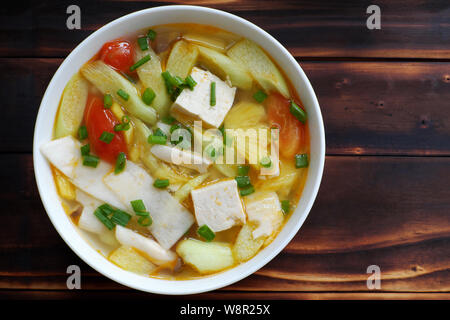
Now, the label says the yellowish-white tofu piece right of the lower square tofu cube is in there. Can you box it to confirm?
[244,192,284,239]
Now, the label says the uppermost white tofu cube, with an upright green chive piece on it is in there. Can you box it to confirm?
[172,67,236,128]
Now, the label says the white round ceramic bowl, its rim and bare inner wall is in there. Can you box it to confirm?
[33,6,325,294]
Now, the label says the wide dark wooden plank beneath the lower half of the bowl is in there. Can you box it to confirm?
[0,154,450,292]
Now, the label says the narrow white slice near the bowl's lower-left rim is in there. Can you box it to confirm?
[116,225,177,265]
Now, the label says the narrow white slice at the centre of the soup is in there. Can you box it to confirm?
[150,145,212,173]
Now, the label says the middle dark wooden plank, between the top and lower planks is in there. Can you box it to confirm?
[0,58,450,155]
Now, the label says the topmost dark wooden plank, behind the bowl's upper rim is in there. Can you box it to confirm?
[0,0,450,59]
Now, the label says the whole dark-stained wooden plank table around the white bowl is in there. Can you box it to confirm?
[0,0,450,299]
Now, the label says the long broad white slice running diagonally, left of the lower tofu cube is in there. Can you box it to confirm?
[103,161,194,249]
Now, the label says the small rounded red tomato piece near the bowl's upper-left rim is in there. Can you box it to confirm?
[100,40,134,72]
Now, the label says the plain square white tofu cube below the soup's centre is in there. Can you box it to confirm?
[191,179,245,232]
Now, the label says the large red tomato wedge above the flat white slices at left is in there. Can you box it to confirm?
[84,95,127,163]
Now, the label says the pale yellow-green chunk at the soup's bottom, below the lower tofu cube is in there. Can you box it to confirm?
[176,239,234,274]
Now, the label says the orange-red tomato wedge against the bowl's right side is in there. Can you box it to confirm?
[265,93,305,158]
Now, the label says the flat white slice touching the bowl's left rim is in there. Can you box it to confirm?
[41,136,125,210]
